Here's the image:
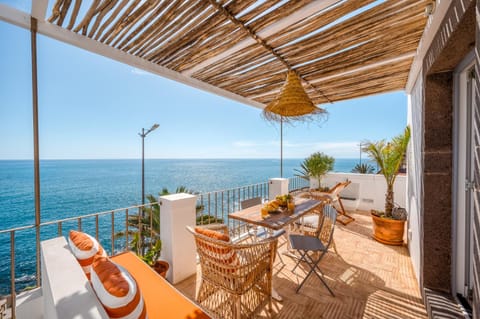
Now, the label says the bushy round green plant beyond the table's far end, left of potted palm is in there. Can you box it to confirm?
[295,152,335,191]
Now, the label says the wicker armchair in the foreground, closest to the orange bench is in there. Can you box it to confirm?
[187,225,277,318]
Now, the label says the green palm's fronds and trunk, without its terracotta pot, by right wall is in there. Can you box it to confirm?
[362,126,410,217]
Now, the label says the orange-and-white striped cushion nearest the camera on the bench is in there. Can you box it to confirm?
[91,256,147,319]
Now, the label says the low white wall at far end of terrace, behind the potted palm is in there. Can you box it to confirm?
[311,173,407,211]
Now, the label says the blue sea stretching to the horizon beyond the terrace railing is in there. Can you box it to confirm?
[0,158,358,295]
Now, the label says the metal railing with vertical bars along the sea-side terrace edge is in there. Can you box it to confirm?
[0,177,308,318]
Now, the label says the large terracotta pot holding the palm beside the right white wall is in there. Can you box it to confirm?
[371,213,405,246]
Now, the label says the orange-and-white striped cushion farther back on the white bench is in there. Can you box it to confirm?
[68,230,107,279]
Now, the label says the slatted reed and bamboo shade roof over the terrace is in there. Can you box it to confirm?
[44,0,431,105]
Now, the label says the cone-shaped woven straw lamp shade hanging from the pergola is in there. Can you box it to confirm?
[263,71,327,122]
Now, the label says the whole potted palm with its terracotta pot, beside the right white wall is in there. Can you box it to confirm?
[362,126,410,245]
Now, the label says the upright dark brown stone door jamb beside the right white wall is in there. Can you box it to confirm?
[422,72,453,293]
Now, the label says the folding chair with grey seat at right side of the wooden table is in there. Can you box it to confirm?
[289,204,337,296]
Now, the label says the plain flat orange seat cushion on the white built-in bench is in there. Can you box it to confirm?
[111,252,210,319]
